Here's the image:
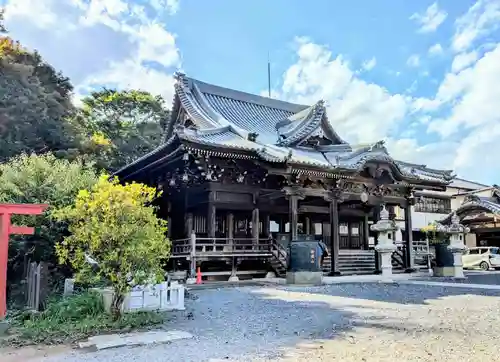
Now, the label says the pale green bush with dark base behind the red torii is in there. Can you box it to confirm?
[0,154,98,296]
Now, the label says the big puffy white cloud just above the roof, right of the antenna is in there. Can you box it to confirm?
[280,38,408,143]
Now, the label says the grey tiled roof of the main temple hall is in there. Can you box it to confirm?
[124,74,453,184]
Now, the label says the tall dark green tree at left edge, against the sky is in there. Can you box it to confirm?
[0,36,79,162]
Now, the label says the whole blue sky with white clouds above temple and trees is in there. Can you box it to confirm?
[0,0,500,183]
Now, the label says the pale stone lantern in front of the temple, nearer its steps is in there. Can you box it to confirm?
[370,205,398,277]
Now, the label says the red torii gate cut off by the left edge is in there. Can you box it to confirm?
[0,204,49,321]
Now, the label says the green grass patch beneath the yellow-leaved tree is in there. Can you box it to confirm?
[8,292,166,345]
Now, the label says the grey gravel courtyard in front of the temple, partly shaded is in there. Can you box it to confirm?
[34,283,500,362]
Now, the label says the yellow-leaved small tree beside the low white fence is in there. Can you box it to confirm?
[56,176,170,318]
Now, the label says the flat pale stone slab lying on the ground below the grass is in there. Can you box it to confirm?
[79,330,193,351]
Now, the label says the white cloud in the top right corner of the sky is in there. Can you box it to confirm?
[452,0,500,52]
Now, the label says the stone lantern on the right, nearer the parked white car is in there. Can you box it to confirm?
[437,213,470,278]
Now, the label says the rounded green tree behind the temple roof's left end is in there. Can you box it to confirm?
[74,89,170,171]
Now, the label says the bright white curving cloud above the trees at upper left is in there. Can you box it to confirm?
[6,0,184,100]
